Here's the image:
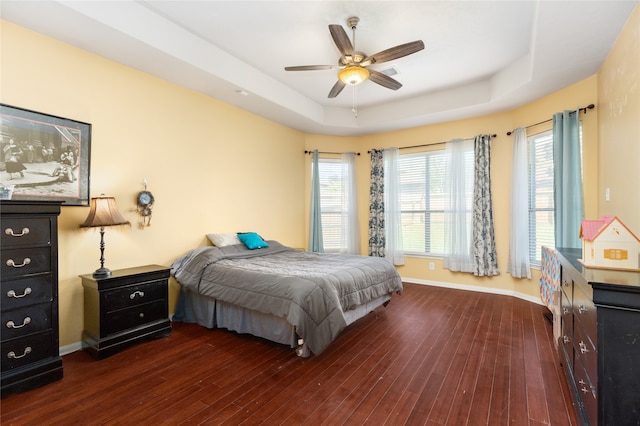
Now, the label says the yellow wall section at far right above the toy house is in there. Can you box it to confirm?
[591,6,640,237]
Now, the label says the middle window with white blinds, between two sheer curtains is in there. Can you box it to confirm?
[398,150,473,256]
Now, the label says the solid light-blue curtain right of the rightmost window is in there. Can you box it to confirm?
[553,111,584,248]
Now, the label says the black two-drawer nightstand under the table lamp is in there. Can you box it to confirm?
[80,265,171,359]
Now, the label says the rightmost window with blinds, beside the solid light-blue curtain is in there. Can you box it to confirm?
[527,130,555,265]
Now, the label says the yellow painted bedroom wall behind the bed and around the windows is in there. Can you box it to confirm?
[0,3,640,352]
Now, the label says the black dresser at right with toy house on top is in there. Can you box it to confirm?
[557,248,640,426]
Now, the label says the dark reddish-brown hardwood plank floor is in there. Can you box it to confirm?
[0,284,577,426]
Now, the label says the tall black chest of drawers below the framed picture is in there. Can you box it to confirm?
[0,201,63,395]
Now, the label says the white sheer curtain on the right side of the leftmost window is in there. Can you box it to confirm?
[340,152,360,254]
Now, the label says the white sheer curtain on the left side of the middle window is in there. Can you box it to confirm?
[383,148,404,265]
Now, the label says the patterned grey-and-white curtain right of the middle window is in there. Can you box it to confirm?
[471,135,500,277]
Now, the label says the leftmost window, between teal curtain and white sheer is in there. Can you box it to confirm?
[318,158,351,253]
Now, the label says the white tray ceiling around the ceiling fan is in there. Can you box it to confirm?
[0,0,638,135]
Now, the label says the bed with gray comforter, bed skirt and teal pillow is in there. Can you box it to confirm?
[171,240,402,356]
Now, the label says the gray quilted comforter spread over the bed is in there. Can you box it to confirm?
[171,241,402,355]
